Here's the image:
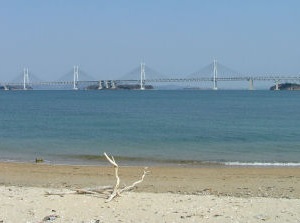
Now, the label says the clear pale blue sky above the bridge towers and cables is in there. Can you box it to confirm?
[0,0,300,81]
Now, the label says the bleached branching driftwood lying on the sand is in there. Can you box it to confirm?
[45,153,149,202]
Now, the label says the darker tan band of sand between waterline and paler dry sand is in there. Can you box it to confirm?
[0,163,300,199]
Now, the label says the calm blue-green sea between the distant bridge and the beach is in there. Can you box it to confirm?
[0,90,300,166]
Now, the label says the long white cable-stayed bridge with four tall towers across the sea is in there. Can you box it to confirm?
[0,60,300,90]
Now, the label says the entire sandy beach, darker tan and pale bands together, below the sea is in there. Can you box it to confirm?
[0,163,300,222]
